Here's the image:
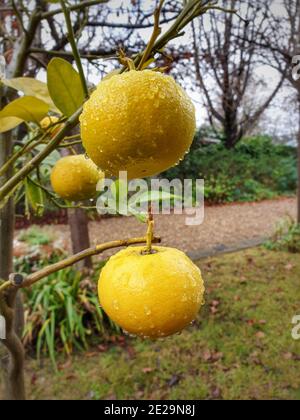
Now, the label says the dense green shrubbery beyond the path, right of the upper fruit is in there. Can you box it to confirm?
[163,136,297,203]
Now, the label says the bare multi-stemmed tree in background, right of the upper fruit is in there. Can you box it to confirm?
[192,0,284,148]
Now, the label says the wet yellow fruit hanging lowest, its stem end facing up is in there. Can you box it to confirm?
[98,247,204,339]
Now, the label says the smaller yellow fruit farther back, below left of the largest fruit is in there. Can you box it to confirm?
[51,155,104,201]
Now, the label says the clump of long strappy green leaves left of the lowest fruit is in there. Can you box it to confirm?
[15,252,119,367]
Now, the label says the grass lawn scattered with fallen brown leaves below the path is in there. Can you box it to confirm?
[2,248,300,400]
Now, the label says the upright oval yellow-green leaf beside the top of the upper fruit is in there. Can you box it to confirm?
[47,58,85,117]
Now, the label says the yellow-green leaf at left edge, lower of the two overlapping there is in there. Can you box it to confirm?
[0,96,49,124]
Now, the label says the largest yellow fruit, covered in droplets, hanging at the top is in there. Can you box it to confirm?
[80,70,196,179]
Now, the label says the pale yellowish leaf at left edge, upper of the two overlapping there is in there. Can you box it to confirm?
[1,77,58,112]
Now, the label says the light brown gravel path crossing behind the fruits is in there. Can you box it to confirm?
[19,198,296,255]
